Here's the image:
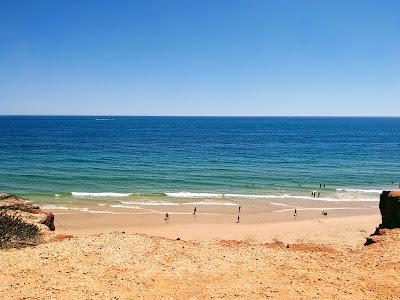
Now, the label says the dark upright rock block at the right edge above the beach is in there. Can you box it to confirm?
[379,191,400,228]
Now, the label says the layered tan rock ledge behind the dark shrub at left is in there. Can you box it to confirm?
[0,193,55,233]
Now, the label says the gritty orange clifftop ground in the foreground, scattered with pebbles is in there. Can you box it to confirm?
[0,232,400,299]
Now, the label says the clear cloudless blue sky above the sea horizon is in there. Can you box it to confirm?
[0,0,400,116]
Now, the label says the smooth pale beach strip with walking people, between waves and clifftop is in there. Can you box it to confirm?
[54,201,380,246]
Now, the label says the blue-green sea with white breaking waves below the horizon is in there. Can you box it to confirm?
[0,116,400,206]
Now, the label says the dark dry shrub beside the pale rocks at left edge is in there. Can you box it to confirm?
[0,211,40,248]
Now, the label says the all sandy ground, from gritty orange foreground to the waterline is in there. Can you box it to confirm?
[0,205,400,299]
